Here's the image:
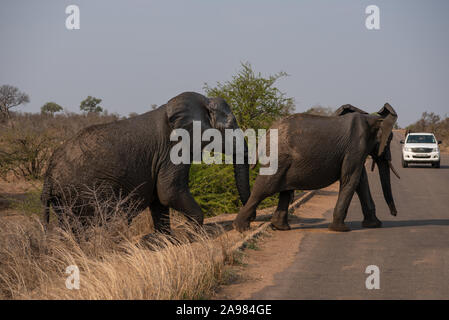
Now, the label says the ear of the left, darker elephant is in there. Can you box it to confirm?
[166,92,210,129]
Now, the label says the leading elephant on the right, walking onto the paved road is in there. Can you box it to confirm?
[234,103,397,231]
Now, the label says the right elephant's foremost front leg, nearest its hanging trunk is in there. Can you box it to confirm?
[356,168,382,228]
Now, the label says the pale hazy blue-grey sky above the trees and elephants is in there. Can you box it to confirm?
[0,0,449,126]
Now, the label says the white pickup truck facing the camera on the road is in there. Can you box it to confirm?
[401,133,441,168]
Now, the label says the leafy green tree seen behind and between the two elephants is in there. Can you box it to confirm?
[189,63,294,215]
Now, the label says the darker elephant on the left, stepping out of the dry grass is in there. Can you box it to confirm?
[41,92,250,233]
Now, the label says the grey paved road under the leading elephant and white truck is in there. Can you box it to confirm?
[252,135,449,299]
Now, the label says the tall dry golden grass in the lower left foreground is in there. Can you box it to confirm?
[0,191,236,299]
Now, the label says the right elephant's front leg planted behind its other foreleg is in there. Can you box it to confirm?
[329,165,361,231]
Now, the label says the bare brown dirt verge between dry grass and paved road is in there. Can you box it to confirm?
[213,184,338,299]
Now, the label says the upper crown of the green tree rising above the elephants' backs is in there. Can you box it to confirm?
[203,62,294,130]
